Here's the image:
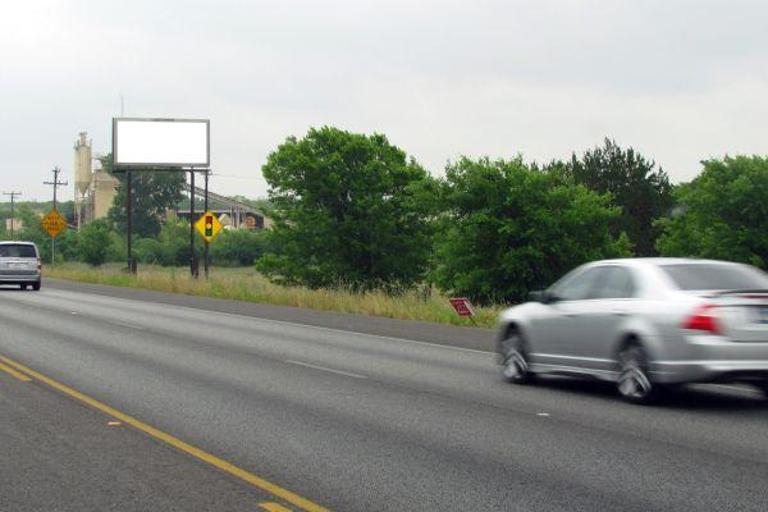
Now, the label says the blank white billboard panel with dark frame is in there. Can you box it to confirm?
[112,117,210,169]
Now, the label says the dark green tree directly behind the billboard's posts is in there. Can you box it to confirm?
[101,154,186,237]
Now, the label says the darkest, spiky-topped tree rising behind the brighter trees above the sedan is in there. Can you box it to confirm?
[566,138,673,256]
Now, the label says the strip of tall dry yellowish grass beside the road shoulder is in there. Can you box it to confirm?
[44,263,501,327]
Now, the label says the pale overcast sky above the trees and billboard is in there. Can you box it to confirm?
[0,0,768,199]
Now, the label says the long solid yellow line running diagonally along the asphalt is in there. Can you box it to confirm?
[0,356,330,512]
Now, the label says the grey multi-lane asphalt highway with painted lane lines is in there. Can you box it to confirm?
[0,283,768,511]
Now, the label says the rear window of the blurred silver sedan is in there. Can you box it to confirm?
[661,263,768,290]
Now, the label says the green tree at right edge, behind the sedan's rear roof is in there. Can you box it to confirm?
[657,156,768,269]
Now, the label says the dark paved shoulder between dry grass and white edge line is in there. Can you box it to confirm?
[43,278,496,352]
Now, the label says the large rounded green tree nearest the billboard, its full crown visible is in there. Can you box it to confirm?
[257,127,434,290]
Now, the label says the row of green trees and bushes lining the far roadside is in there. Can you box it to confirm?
[3,127,768,303]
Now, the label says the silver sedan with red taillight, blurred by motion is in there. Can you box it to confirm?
[497,258,768,403]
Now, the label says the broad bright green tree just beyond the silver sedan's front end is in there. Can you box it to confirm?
[432,157,630,304]
